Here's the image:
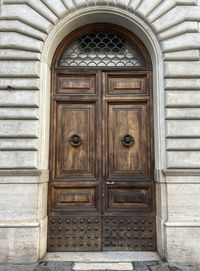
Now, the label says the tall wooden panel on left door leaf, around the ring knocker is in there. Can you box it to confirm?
[56,103,96,177]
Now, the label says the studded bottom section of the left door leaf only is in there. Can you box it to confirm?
[48,216,101,251]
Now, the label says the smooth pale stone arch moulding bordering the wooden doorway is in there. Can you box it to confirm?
[40,7,165,260]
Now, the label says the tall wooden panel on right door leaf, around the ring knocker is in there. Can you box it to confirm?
[107,102,149,178]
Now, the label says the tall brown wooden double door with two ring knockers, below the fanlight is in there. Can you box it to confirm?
[48,69,156,251]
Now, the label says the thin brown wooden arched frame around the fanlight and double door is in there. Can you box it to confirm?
[48,23,155,253]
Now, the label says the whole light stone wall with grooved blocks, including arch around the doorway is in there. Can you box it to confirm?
[0,0,200,263]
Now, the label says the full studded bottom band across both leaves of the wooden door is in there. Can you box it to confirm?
[48,216,156,251]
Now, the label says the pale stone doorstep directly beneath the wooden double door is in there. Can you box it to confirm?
[43,251,161,263]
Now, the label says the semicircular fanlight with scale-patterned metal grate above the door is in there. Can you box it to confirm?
[59,31,145,67]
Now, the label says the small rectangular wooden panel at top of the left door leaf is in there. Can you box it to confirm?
[57,74,96,95]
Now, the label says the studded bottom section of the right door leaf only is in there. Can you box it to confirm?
[102,217,156,251]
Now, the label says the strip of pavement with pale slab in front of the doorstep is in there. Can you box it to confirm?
[0,260,200,271]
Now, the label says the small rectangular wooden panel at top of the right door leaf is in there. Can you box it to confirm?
[106,73,149,96]
